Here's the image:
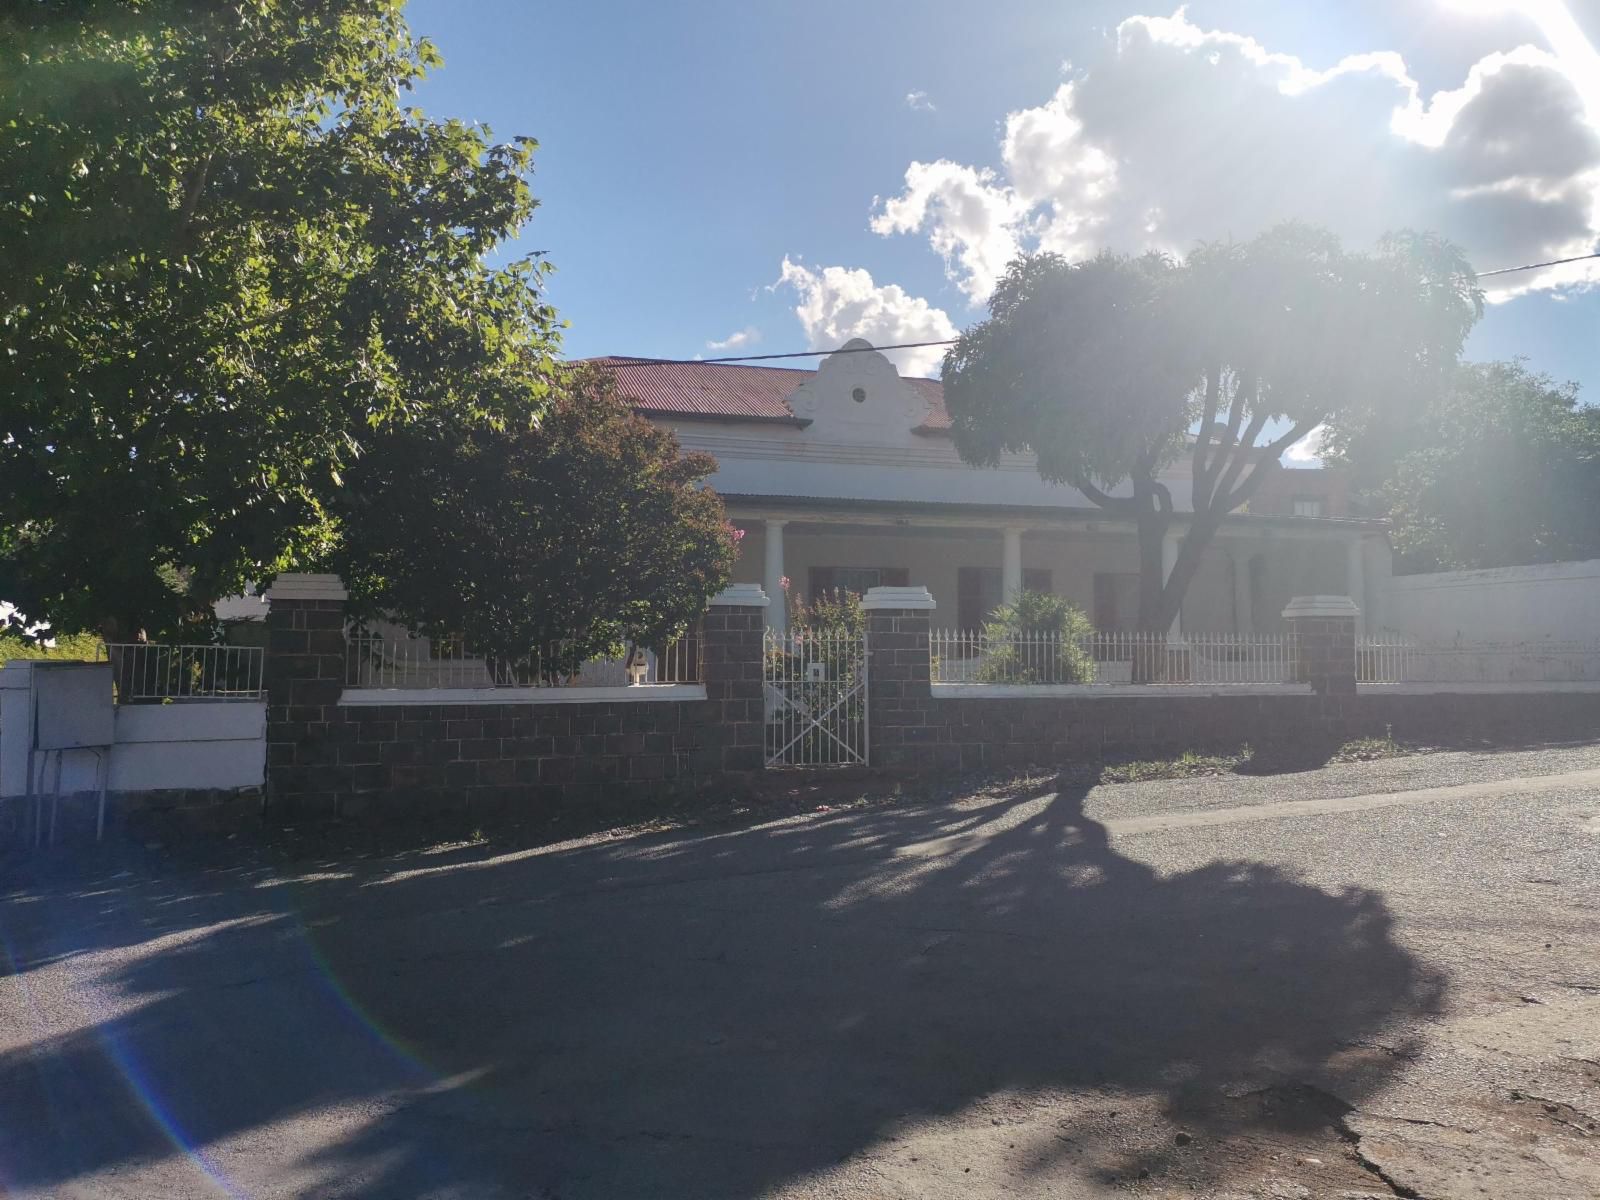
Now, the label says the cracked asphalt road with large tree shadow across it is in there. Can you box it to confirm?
[0,747,1600,1200]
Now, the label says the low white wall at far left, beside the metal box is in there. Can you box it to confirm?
[0,662,267,797]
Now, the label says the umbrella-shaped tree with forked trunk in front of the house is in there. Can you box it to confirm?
[944,224,1482,630]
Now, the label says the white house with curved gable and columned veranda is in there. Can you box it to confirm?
[597,339,1390,634]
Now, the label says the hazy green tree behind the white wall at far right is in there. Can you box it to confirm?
[1325,362,1600,571]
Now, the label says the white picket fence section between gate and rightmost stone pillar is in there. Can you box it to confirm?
[930,629,1296,686]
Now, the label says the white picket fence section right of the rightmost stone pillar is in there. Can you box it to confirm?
[1355,634,1600,683]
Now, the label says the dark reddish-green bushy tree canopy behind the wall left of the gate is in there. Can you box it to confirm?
[336,368,738,678]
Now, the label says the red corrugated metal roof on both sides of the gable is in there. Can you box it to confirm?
[589,357,950,429]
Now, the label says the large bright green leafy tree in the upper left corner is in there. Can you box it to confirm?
[0,0,557,637]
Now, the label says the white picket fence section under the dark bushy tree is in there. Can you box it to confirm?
[344,630,701,688]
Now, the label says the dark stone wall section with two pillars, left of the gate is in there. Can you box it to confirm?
[267,576,765,821]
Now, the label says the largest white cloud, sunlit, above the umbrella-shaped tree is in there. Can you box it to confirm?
[872,8,1600,299]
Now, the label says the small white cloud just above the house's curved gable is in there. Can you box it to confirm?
[773,256,955,376]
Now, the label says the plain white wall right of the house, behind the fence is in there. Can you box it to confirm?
[1384,560,1600,642]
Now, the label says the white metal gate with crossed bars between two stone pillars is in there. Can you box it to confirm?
[762,629,867,768]
